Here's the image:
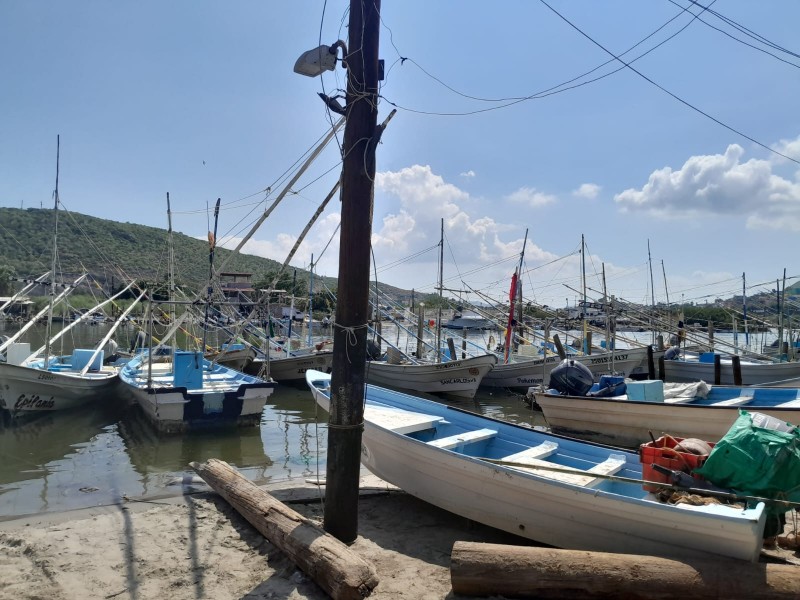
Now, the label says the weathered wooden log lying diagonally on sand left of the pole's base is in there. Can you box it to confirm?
[189,458,378,600]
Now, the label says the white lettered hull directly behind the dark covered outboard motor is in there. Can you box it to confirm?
[481,348,647,391]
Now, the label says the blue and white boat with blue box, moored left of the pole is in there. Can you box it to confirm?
[119,348,277,433]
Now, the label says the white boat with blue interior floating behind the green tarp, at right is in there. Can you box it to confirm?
[529,380,800,447]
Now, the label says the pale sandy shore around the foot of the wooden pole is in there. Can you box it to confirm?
[0,476,800,600]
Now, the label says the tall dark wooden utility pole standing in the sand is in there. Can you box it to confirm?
[324,0,381,544]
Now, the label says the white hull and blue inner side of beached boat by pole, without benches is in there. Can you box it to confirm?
[308,373,766,561]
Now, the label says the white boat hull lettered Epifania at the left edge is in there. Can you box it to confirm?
[0,363,119,415]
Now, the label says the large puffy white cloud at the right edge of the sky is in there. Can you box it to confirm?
[614,144,800,231]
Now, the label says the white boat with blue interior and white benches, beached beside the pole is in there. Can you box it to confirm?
[306,371,766,561]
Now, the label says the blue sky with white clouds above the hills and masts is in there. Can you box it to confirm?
[0,0,800,314]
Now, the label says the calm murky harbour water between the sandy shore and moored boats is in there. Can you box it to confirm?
[0,318,542,518]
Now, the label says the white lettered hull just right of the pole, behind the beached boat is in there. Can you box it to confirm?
[365,354,497,398]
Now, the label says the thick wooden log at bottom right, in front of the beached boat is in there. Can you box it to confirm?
[450,542,800,600]
